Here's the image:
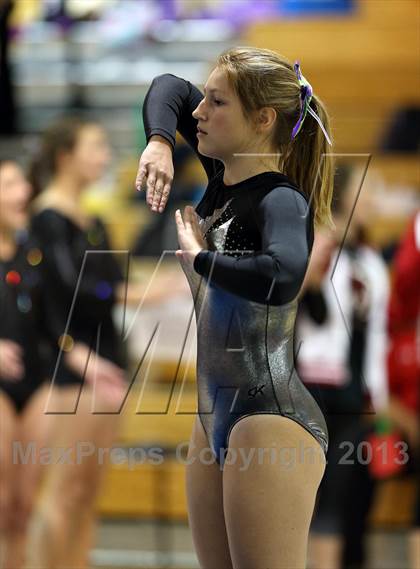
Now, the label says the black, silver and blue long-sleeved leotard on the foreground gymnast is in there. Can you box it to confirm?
[143,74,328,462]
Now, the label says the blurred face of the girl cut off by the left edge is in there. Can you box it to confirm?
[0,161,32,231]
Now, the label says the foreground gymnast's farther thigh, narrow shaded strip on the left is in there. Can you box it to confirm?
[186,415,232,569]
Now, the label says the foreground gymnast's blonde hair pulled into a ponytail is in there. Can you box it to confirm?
[216,47,334,226]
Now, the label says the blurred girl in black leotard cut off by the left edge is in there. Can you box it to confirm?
[0,159,48,569]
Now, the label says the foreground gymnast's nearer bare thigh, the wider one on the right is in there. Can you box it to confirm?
[223,414,325,569]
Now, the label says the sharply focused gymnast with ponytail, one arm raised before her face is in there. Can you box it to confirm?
[136,47,333,569]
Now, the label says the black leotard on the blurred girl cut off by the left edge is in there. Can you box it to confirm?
[0,232,47,412]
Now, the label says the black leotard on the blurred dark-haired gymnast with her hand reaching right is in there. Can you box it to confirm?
[32,209,126,385]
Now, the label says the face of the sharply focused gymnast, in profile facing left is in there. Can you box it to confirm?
[192,67,255,163]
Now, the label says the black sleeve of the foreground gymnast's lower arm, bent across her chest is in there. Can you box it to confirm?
[194,187,309,305]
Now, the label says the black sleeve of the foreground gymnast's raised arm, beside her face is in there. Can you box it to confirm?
[143,73,221,179]
